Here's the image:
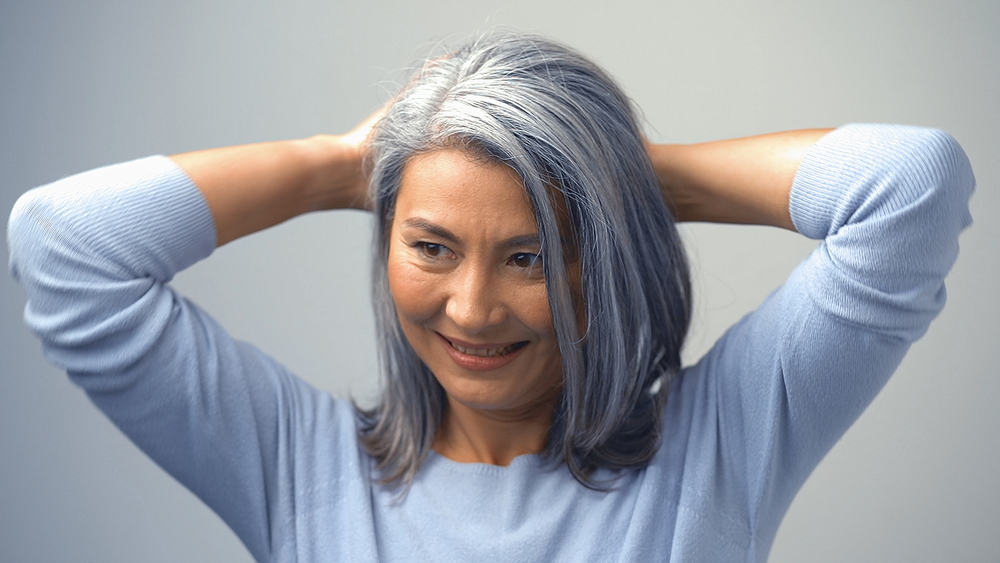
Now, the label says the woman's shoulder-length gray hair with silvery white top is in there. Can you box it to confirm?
[358,33,690,489]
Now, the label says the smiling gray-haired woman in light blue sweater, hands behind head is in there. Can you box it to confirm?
[9,35,974,561]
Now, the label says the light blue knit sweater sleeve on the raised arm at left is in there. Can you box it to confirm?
[7,157,332,560]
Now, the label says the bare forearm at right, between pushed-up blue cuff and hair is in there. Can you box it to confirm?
[646,129,830,230]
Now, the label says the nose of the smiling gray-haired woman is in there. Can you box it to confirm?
[445,265,506,334]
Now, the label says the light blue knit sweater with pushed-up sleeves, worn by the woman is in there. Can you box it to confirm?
[8,125,974,562]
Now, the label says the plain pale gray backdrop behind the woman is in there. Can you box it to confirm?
[0,0,1000,562]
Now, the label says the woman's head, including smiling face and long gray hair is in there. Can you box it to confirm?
[362,30,689,486]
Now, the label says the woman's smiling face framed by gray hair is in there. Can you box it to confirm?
[388,149,562,416]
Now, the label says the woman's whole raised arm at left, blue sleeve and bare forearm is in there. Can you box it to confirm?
[8,111,380,560]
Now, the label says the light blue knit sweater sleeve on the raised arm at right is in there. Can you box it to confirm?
[677,125,975,559]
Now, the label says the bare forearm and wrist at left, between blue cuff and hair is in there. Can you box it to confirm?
[170,107,385,246]
